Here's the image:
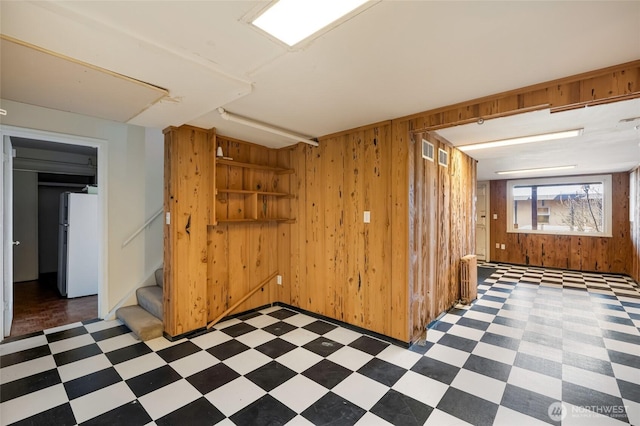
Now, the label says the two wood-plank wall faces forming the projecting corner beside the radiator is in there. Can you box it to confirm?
[279,122,476,342]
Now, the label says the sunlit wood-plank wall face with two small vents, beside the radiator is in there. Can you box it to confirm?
[406,127,476,341]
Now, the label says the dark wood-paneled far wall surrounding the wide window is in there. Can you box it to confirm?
[490,173,633,274]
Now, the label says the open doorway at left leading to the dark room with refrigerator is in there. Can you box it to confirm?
[0,126,106,339]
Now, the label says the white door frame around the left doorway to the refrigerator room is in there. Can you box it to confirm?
[0,125,109,341]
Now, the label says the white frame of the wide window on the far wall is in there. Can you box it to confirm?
[506,175,613,238]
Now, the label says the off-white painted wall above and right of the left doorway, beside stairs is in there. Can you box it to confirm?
[1,100,163,315]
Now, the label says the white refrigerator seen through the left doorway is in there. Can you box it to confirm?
[58,192,99,298]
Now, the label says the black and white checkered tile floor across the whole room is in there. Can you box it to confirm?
[0,265,640,426]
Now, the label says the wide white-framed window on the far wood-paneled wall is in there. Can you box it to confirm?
[507,175,612,237]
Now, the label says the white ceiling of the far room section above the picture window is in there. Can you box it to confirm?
[437,99,640,180]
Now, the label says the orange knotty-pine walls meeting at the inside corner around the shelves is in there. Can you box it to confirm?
[208,122,411,341]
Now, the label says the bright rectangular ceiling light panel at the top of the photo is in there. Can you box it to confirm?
[252,0,367,46]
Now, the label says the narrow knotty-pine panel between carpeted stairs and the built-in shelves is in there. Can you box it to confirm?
[164,126,215,336]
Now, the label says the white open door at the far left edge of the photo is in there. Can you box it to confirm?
[0,136,13,337]
